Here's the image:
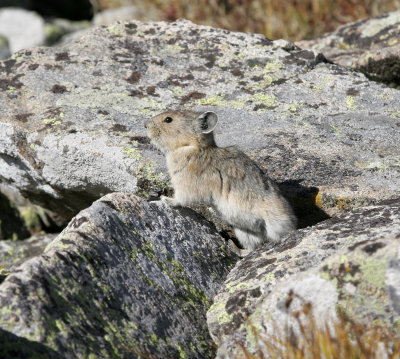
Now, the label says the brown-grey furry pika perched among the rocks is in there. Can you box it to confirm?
[145,111,296,254]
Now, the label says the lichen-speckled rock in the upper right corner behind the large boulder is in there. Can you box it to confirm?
[296,10,400,86]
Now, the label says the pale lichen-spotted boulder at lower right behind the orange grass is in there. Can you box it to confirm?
[207,199,400,358]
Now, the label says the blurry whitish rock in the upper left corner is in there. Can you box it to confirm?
[0,8,45,53]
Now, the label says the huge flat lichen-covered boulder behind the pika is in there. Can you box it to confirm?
[0,21,400,223]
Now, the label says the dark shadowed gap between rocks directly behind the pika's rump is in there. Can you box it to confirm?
[278,180,330,229]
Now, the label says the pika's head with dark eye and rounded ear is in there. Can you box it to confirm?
[145,111,218,152]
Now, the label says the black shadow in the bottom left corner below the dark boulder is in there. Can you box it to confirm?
[0,329,62,359]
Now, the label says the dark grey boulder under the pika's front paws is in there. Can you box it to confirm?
[0,193,236,358]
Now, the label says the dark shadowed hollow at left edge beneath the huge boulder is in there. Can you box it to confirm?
[0,192,29,242]
